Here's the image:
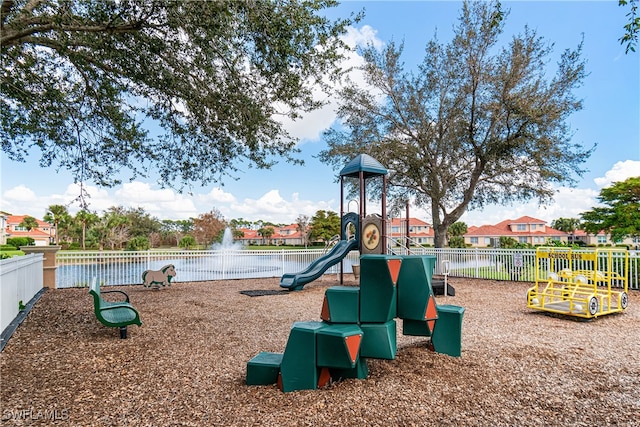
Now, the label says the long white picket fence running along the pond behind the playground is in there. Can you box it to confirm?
[56,248,640,289]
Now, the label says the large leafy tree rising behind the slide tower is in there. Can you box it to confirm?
[321,2,591,247]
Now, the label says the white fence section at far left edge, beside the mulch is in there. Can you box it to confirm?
[0,254,44,331]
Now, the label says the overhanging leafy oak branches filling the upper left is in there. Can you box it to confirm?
[0,0,358,188]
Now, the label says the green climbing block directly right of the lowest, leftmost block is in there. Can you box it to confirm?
[279,321,324,392]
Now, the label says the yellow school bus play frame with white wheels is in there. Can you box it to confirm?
[527,247,629,319]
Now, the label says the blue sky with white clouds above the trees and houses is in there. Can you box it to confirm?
[0,0,640,225]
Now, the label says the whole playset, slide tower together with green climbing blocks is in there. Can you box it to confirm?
[251,154,464,392]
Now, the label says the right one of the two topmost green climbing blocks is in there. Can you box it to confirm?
[397,255,436,320]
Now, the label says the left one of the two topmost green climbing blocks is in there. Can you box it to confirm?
[360,255,401,323]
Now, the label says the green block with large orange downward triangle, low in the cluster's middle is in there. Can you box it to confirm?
[316,323,363,368]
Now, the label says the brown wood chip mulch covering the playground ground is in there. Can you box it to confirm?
[0,275,640,427]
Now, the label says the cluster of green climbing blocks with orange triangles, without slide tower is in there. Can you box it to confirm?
[246,254,464,392]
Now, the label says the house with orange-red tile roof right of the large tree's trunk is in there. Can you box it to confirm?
[464,216,568,247]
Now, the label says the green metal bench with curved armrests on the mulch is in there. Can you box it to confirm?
[89,277,142,339]
